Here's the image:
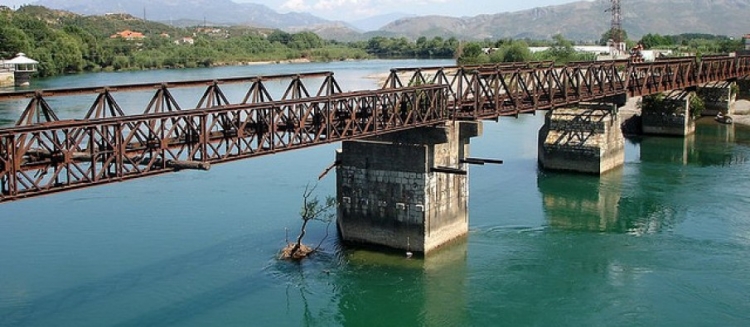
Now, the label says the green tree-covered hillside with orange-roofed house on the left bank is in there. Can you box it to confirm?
[0,6,368,76]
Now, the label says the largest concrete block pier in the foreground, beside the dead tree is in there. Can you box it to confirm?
[336,122,482,253]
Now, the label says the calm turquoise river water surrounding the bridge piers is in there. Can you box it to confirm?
[0,61,750,327]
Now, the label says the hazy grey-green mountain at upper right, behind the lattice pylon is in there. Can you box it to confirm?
[381,0,750,41]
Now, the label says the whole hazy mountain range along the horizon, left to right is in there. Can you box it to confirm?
[35,0,750,41]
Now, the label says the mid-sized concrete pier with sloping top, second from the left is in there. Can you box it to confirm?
[539,104,625,175]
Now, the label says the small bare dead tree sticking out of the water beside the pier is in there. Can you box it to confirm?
[281,185,336,260]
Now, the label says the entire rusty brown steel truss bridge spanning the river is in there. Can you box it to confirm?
[0,56,750,202]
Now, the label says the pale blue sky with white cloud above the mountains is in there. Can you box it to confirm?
[0,0,588,21]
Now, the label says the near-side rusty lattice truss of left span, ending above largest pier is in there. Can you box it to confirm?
[0,85,449,201]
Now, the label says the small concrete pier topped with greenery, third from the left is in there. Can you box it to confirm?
[641,90,696,136]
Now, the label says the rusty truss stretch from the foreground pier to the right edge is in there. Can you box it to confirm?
[383,55,750,103]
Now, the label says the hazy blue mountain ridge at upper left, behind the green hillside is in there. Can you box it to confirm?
[35,0,328,29]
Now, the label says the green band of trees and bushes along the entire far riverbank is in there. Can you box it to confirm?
[0,6,742,76]
